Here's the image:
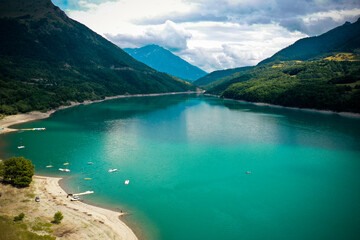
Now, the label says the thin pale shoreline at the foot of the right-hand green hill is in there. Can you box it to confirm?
[204,93,360,118]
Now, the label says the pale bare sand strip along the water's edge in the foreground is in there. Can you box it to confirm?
[33,175,138,240]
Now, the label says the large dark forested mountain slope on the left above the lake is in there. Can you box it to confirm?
[0,0,195,114]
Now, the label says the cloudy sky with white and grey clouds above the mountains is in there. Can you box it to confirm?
[52,0,360,72]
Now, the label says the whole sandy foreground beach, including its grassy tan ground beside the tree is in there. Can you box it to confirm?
[0,176,138,240]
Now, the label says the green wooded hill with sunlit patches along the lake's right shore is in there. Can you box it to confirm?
[207,60,360,113]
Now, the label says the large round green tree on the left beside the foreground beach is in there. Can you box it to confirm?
[3,157,34,187]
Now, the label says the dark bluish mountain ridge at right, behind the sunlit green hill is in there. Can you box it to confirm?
[259,18,360,65]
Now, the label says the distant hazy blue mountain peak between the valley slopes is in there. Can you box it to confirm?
[124,45,207,81]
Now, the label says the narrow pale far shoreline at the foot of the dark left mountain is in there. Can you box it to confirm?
[0,91,202,134]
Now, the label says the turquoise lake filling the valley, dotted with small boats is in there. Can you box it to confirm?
[0,95,360,240]
